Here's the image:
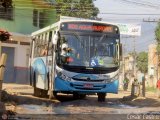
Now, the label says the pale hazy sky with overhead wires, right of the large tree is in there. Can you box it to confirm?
[94,0,160,53]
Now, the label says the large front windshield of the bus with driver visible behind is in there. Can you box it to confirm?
[57,32,118,68]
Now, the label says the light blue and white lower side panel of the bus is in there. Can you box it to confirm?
[32,58,48,90]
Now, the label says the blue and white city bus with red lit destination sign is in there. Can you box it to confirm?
[29,20,121,101]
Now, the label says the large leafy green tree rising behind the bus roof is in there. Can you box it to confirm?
[55,0,99,18]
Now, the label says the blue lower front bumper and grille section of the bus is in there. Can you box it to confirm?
[55,77,119,94]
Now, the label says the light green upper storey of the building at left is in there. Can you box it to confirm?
[0,0,56,34]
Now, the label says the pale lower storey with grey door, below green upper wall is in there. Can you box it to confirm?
[0,34,30,83]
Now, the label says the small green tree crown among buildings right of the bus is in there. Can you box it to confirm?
[136,52,148,73]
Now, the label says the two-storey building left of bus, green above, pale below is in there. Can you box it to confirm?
[0,0,56,83]
